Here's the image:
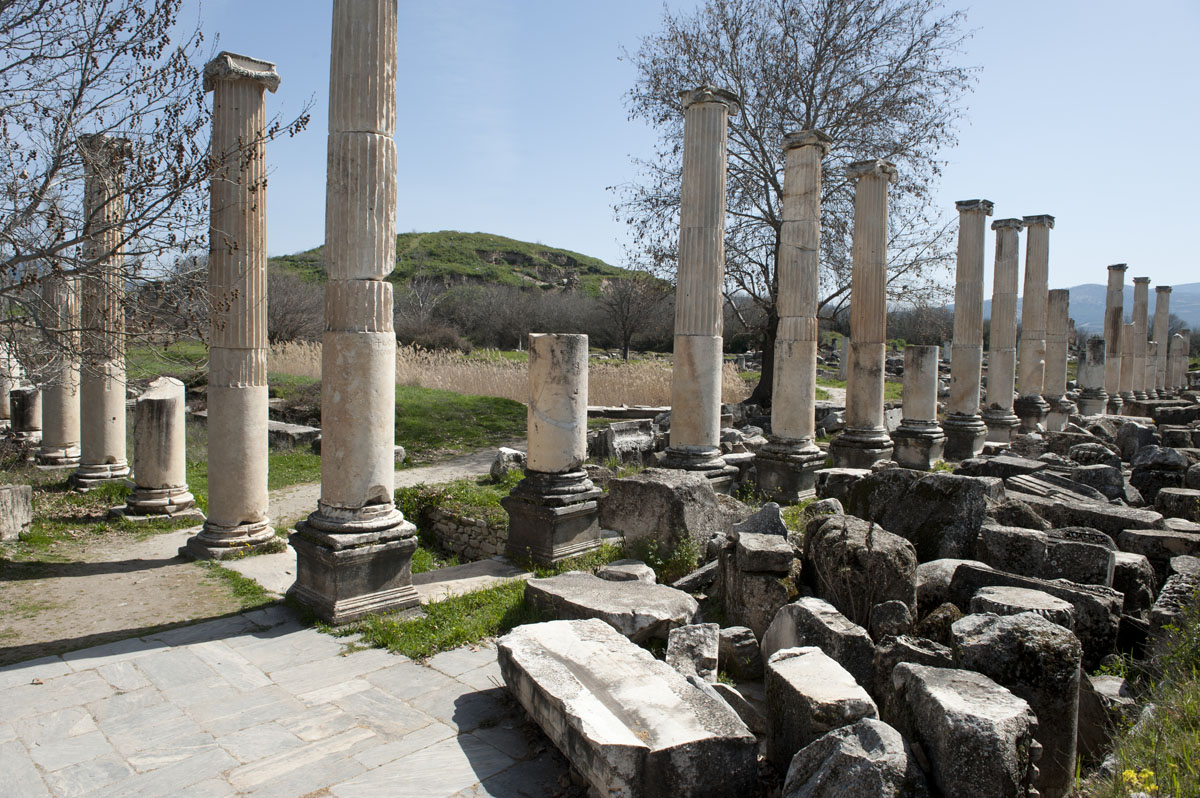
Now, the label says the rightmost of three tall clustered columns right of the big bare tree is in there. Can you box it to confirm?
[1013,215,1054,432]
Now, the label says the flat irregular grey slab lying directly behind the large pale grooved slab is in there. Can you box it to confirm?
[524,571,700,643]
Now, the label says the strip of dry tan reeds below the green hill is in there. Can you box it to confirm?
[269,342,750,406]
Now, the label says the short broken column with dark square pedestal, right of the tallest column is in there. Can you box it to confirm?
[500,334,601,563]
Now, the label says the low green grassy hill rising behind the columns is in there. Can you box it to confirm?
[270,230,630,293]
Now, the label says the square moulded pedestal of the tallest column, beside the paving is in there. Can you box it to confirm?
[288,513,420,625]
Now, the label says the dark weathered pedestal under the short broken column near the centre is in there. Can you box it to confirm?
[500,470,602,564]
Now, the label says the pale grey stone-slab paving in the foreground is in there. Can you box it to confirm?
[0,606,575,798]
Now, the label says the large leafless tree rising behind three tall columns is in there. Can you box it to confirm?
[614,0,972,403]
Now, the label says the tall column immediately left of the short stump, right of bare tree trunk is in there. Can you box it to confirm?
[829,161,896,468]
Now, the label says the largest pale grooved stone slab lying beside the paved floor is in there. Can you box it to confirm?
[497,619,757,798]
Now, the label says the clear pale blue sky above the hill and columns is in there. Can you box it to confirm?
[185,0,1200,295]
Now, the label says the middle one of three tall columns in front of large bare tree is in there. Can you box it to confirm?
[755,131,830,502]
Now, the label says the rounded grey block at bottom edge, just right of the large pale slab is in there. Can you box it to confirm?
[784,718,929,798]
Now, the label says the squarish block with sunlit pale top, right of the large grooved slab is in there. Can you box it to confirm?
[766,646,880,770]
